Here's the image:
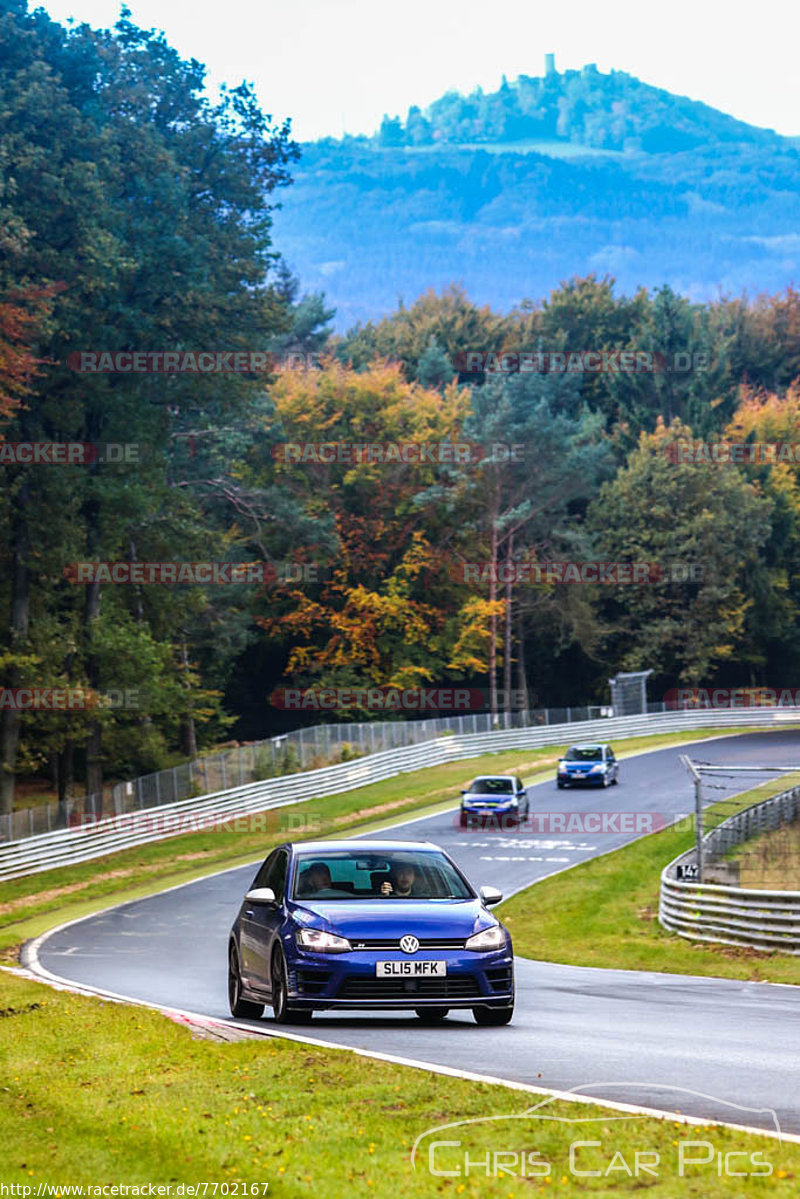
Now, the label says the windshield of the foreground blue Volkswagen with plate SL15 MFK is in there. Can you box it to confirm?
[291,850,473,900]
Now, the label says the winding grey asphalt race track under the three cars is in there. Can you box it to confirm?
[29,729,800,1134]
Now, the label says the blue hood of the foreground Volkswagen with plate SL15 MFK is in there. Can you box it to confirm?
[291,899,497,940]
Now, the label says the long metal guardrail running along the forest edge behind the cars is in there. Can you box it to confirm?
[0,709,800,880]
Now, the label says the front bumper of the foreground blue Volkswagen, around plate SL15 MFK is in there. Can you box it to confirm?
[288,947,513,1011]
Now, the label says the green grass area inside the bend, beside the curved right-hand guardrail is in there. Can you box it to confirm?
[497,779,800,983]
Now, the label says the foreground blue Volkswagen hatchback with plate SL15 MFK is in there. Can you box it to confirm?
[228,840,513,1025]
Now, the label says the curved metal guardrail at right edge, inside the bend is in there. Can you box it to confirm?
[658,787,800,954]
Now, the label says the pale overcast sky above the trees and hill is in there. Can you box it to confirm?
[42,0,800,140]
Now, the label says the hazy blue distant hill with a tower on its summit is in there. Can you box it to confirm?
[275,66,800,330]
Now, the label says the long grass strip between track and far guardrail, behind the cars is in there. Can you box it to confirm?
[0,725,741,960]
